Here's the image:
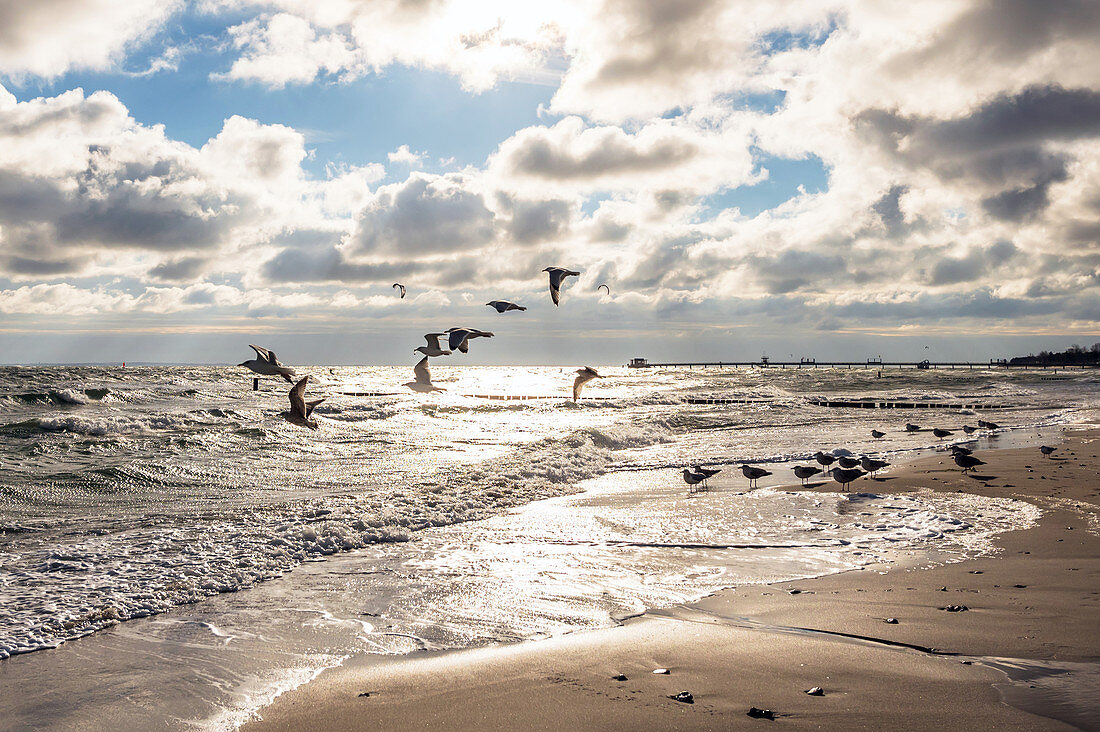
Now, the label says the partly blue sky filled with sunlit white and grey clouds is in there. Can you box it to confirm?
[0,0,1100,364]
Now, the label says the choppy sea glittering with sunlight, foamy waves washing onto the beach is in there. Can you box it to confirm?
[0,363,1100,729]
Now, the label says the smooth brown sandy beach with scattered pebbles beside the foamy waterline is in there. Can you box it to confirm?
[244,430,1100,731]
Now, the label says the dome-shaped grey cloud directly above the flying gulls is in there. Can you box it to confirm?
[353,176,495,254]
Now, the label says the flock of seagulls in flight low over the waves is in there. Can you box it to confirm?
[239,266,616,424]
